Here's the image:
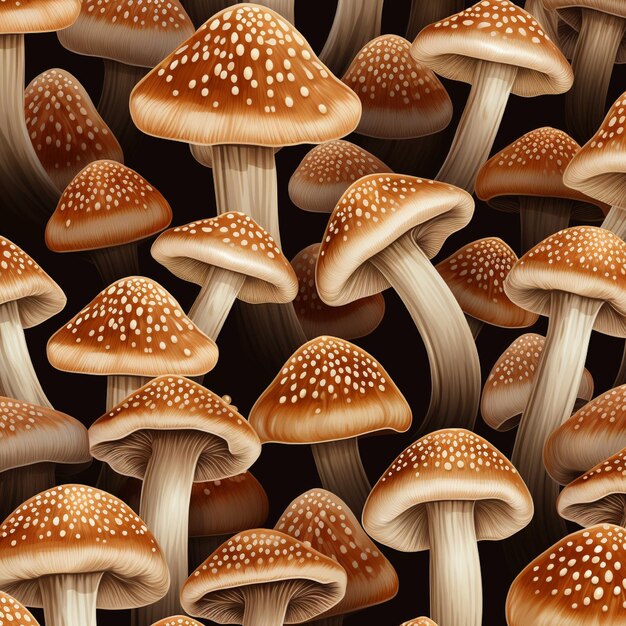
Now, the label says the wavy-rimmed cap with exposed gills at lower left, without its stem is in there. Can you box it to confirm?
[89,375,261,481]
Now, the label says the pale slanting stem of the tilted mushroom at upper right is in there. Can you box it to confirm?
[436,61,517,193]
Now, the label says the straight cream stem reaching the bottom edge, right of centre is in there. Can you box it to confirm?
[426,501,483,626]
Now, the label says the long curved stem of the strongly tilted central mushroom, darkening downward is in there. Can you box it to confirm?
[370,233,480,433]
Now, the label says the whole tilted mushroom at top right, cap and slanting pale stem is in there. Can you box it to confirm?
[411,0,573,192]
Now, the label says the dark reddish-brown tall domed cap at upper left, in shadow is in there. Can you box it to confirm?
[24,68,124,191]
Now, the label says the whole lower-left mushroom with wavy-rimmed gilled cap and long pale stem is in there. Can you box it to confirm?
[89,375,261,624]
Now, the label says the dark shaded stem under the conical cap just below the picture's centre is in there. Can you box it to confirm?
[311,437,372,517]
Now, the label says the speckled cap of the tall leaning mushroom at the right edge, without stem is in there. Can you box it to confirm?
[504,226,626,337]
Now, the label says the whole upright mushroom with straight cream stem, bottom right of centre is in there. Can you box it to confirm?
[363,428,533,626]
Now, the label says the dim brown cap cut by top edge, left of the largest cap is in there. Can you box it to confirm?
[58,0,195,67]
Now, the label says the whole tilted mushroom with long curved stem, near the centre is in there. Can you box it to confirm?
[316,174,480,432]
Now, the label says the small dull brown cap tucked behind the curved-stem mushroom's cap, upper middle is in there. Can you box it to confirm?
[289,139,391,213]
